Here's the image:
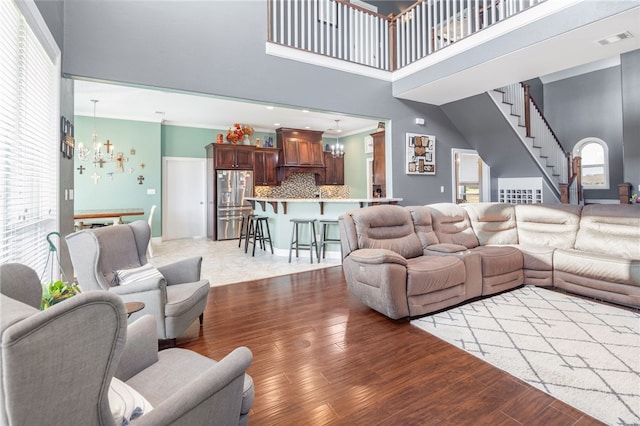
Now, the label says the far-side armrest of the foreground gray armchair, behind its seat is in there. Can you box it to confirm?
[114,315,158,382]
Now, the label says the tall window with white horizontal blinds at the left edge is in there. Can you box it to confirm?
[0,0,60,274]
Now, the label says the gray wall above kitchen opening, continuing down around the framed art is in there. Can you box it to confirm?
[50,1,469,204]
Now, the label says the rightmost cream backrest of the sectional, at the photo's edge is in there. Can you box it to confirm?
[575,204,640,259]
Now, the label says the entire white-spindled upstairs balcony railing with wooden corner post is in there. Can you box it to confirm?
[267,0,545,71]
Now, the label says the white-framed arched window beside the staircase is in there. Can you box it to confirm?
[573,138,609,189]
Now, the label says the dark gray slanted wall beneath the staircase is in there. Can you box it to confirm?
[441,93,552,201]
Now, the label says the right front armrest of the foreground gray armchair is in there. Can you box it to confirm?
[131,347,253,426]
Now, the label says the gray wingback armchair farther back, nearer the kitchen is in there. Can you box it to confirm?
[66,220,210,343]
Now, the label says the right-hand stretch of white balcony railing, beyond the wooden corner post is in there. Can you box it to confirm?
[394,0,545,68]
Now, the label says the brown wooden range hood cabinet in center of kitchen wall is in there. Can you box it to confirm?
[276,128,324,167]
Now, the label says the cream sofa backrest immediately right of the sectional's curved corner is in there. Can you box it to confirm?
[515,204,582,249]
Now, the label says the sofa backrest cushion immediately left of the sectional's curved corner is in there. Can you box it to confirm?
[427,203,479,249]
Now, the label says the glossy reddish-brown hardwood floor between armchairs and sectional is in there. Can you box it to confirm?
[178,267,601,426]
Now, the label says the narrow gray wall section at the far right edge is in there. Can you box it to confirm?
[620,50,640,193]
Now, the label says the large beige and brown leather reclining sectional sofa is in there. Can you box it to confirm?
[339,203,640,319]
